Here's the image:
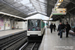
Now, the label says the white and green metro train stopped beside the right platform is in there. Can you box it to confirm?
[27,19,45,42]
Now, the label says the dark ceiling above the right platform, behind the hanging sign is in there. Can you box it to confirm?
[53,0,75,21]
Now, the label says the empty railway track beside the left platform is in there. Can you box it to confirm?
[0,32,27,50]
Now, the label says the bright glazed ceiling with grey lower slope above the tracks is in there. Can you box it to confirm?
[0,0,47,18]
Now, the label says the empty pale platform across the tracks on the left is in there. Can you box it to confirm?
[0,29,25,38]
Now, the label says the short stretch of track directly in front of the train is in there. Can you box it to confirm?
[19,42,40,50]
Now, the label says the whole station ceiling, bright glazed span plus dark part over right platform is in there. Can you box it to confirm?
[0,0,75,20]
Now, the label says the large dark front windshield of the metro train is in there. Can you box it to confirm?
[28,20,41,31]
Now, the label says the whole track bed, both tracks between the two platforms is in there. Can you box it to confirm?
[0,32,40,50]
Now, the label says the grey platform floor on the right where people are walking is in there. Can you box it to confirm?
[39,29,75,50]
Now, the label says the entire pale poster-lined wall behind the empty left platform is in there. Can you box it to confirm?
[0,18,27,31]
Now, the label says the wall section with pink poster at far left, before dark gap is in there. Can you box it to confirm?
[0,18,13,31]
